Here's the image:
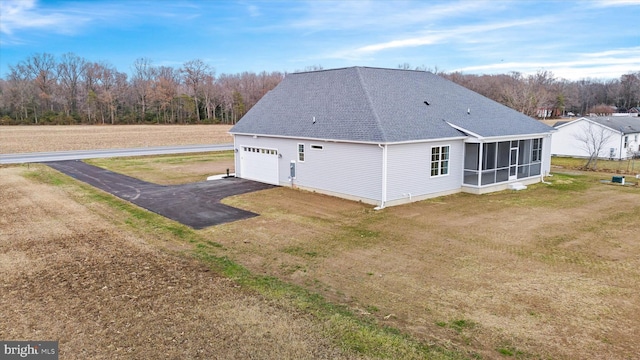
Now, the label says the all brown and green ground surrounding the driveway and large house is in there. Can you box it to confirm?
[0,125,640,359]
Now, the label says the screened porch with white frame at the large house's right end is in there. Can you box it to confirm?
[463,137,543,193]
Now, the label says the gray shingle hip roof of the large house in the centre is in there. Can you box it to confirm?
[231,67,552,143]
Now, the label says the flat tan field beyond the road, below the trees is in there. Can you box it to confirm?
[0,125,233,154]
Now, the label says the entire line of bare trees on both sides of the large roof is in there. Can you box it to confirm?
[0,53,640,124]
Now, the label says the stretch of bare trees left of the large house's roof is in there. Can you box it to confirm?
[0,53,284,124]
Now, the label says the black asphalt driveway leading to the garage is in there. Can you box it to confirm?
[45,160,274,229]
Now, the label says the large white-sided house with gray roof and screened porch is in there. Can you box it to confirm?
[230,67,553,208]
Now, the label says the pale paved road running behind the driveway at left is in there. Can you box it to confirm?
[0,144,233,164]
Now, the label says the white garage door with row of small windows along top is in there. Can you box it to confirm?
[240,146,280,185]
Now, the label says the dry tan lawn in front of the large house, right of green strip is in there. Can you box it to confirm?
[219,183,640,359]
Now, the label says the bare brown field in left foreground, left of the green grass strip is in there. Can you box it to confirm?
[0,167,364,359]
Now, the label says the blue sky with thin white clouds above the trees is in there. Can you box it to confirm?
[0,0,640,80]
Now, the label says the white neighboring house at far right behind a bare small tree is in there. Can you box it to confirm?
[551,116,640,160]
